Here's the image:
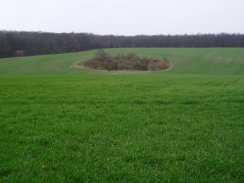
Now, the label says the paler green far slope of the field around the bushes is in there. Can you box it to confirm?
[0,48,244,75]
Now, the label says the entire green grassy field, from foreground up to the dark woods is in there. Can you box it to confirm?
[0,48,244,182]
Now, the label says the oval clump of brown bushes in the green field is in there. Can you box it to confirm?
[83,49,170,71]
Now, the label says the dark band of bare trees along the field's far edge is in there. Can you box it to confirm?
[0,31,244,57]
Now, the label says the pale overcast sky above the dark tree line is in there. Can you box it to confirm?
[0,0,244,35]
